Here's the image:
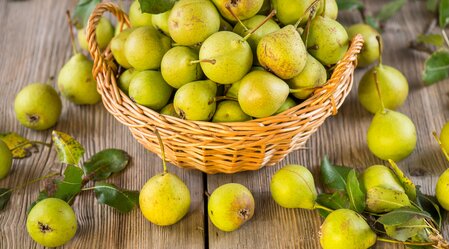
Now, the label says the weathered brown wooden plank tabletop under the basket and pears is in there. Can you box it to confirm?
[0,0,449,249]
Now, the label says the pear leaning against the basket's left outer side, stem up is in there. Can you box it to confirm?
[58,53,101,105]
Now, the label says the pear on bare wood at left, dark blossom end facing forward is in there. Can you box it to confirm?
[14,83,62,130]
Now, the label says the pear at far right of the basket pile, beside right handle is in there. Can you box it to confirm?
[304,16,349,65]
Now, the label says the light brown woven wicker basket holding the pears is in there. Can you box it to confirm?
[87,3,363,174]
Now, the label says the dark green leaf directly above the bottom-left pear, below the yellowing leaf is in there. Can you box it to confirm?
[52,165,83,204]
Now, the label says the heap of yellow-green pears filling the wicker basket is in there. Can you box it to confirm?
[108,0,349,122]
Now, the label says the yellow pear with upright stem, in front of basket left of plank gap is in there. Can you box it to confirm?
[139,172,190,226]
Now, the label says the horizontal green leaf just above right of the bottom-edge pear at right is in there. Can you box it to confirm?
[377,207,432,226]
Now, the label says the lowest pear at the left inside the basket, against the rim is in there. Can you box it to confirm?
[129,70,173,111]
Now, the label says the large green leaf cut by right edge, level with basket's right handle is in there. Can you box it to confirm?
[422,50,449,85]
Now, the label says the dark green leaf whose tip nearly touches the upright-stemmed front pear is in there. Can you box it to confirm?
[94,183,139,213]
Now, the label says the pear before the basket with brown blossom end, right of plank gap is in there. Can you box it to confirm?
[207,183,255,232]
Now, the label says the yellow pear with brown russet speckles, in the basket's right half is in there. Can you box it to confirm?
[257,25,307,79]
